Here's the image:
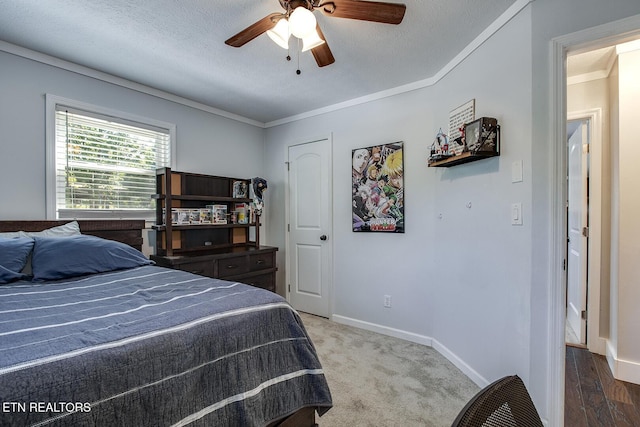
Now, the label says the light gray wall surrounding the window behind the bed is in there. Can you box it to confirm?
[0,51,264,219]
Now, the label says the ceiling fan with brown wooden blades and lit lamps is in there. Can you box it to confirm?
[225,0,406,67]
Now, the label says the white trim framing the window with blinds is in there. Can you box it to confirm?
[45,93,177,219]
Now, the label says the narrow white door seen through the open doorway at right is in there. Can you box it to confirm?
[567,121,589,344]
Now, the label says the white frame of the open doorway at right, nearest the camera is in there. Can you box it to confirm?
[547,15,640,425]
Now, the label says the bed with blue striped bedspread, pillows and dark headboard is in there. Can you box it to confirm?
[0,221,332,427]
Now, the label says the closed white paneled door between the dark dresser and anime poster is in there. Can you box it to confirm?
[287,139,332,317]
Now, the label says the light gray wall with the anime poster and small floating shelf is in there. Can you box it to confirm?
[266,0,532,404]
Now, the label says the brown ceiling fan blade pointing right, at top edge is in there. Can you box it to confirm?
[317,0,407,25]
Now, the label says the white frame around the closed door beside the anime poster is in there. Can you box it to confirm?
[284,133,335,319]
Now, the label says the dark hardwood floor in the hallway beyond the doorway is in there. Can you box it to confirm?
[564,346,640,427]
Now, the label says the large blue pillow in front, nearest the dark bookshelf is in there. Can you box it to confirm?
[31,235,153,280]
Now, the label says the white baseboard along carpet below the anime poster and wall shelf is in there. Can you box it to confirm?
[331,314,489,388]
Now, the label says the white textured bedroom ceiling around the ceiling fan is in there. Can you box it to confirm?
[0,0,516,123]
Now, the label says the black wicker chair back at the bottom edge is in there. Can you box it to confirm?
[451,375,542,427]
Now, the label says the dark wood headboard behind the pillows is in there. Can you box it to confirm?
[0,220,145,250]
